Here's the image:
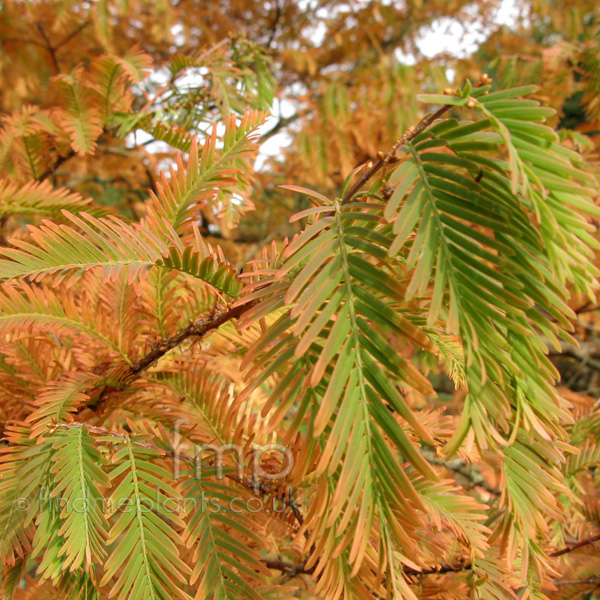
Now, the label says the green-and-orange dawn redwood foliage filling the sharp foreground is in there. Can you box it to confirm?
[0,1,600,600]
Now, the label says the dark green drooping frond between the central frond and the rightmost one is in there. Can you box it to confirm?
[385,97,581,452]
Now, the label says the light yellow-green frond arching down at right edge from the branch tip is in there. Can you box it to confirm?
[477,88,600,294]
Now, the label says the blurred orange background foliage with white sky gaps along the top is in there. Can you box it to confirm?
[0,0,600,261]
